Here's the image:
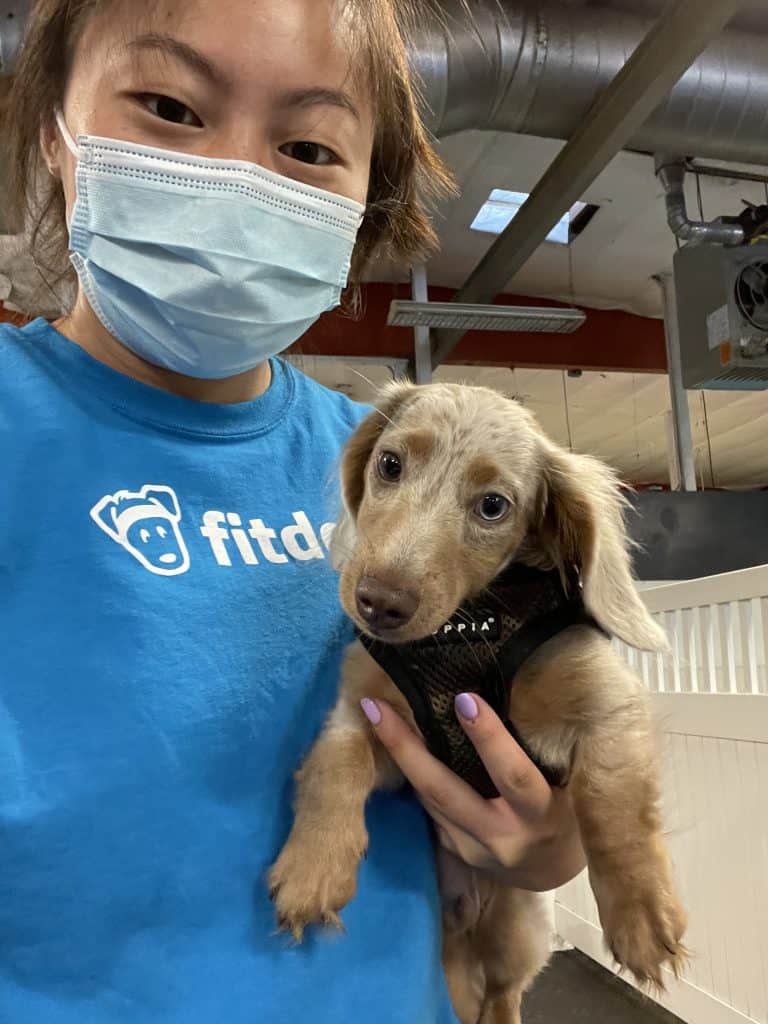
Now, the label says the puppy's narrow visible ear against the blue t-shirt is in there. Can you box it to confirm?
[331,381,419,569]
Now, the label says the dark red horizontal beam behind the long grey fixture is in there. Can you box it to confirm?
[292,284,667,373]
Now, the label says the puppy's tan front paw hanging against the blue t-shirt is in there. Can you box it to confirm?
[269,833,368,942]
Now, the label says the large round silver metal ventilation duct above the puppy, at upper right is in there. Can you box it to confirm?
[413,0,768,164]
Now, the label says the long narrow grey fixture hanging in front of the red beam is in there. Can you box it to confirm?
[387,299,587,334]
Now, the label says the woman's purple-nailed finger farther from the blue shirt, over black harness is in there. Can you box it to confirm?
[456,693,552,821]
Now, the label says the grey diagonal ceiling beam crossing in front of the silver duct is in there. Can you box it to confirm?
[432,0,744,367]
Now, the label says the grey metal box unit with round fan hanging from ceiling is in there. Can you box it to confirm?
[675,242,768,391]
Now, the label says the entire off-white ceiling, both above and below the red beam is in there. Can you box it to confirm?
[339,0,768,487]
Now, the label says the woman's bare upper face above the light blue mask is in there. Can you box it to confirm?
[43,0,374,214]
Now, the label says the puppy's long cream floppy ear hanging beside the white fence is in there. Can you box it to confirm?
[539,441,668,650]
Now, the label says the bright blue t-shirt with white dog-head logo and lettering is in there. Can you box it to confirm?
[0,321,455,1024]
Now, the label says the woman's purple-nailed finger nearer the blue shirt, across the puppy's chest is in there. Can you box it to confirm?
[360,698,497,837]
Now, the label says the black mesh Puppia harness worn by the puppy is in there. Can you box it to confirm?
[357,562,602,799]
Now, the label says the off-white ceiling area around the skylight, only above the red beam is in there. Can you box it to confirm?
[369,131,768,316]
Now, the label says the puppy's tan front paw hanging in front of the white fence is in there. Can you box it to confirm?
[603,891,688,989]
